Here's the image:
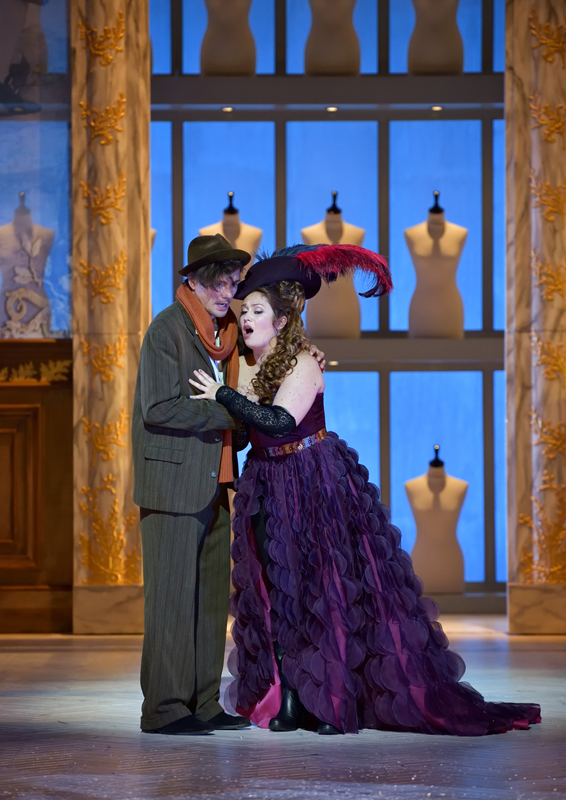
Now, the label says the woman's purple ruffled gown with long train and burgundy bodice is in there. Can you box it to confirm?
[228,395,540,736]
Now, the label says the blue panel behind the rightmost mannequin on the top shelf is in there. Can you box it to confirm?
[389,0,482,72]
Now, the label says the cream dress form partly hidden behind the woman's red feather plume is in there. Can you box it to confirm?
[301,192,365,339]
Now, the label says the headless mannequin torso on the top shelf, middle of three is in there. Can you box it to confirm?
[305,0,360,75]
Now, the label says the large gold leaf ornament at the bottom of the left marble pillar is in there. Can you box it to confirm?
[79,474,142,586]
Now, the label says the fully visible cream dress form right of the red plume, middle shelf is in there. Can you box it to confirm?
[405,192,468,339]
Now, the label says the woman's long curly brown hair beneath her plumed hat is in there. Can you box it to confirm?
[248,281,311,405]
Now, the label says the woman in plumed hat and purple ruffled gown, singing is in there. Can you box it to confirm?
[192,245,540,736]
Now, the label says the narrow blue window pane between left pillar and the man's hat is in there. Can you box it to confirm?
[151,122,173,316]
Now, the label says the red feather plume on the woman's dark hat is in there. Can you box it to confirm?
[295,244,393,297]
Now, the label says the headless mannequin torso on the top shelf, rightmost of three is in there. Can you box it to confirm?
[409,0,464,75]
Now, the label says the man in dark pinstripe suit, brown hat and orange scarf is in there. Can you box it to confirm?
[132,234,250,735]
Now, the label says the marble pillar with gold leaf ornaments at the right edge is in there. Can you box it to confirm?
[505,0,566,633]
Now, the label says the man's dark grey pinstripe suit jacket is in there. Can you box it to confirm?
[132,301,237,514]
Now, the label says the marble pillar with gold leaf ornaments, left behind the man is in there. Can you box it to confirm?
[70,0,150,633]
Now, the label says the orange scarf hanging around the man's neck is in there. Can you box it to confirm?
[175,283,240,483]
